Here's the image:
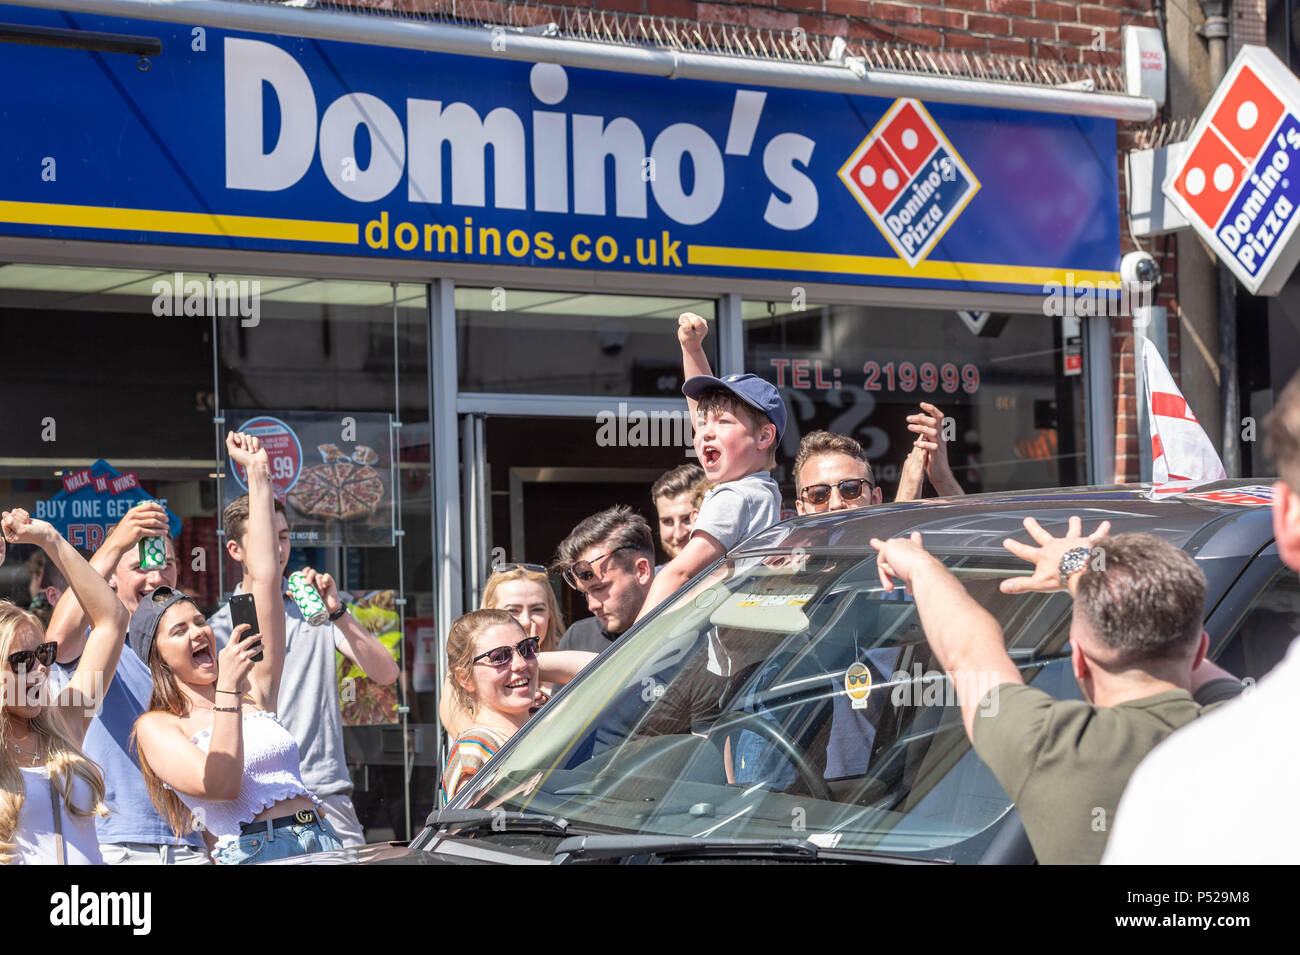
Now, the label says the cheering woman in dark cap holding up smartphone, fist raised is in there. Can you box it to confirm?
[130,434,342,864]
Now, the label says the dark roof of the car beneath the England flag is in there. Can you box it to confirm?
[733,478,1273,559]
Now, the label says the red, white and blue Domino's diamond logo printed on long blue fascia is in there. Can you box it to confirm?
[840,100,980,266]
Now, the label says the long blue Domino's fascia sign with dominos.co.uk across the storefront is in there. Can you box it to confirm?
[0,6,1119,296]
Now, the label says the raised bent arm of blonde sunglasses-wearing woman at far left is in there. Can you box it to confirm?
[0,508,127,743]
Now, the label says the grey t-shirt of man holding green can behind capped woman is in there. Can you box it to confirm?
[208,587,352,796]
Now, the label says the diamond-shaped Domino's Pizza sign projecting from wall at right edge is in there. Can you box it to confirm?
[1164,45,1300,295]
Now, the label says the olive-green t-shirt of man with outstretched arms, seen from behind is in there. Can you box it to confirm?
[974,683,1203,865]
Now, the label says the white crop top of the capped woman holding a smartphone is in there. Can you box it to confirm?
[177,709,320,841]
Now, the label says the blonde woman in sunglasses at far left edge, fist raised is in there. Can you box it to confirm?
[0,508,126,865]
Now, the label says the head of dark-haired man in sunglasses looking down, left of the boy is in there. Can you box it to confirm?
[555,504,654,654]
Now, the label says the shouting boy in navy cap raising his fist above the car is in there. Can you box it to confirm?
[637,312,785,620]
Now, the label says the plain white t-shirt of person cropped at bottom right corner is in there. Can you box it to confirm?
[1101,639,1300,865]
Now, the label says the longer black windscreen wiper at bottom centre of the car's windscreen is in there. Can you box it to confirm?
[553,834,930,865]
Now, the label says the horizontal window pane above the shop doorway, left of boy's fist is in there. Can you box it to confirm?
[456,287,718,398]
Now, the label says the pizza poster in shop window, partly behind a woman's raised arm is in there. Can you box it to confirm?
[226,411,393,547]
